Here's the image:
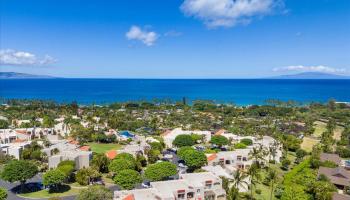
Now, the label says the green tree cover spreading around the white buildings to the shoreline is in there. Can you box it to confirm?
[0,100,350,200]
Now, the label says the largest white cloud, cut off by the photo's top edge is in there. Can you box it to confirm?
[180,0,283,28]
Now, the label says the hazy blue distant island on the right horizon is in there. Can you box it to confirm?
[268,72,350,79]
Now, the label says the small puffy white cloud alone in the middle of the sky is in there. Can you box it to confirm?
[125,26,158,46]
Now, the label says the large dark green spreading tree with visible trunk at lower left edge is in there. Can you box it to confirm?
[1,160,38,191]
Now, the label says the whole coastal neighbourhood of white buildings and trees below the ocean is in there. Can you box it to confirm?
[0,102,350,200]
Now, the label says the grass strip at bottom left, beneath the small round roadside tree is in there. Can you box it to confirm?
[18,186,80,199]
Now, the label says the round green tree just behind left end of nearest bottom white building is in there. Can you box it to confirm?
[113,169,142,190]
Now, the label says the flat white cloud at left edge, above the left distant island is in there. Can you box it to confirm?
[0,49,57,66]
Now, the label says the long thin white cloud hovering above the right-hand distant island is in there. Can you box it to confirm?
[273,65,347,74]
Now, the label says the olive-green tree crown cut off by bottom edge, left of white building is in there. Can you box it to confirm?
[76,185,113,200]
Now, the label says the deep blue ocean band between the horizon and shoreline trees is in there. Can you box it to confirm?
[0,79,350,105]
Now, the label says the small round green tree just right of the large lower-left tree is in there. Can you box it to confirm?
[43,169,66,192]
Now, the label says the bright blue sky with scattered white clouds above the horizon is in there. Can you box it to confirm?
[0,0,350,78]
